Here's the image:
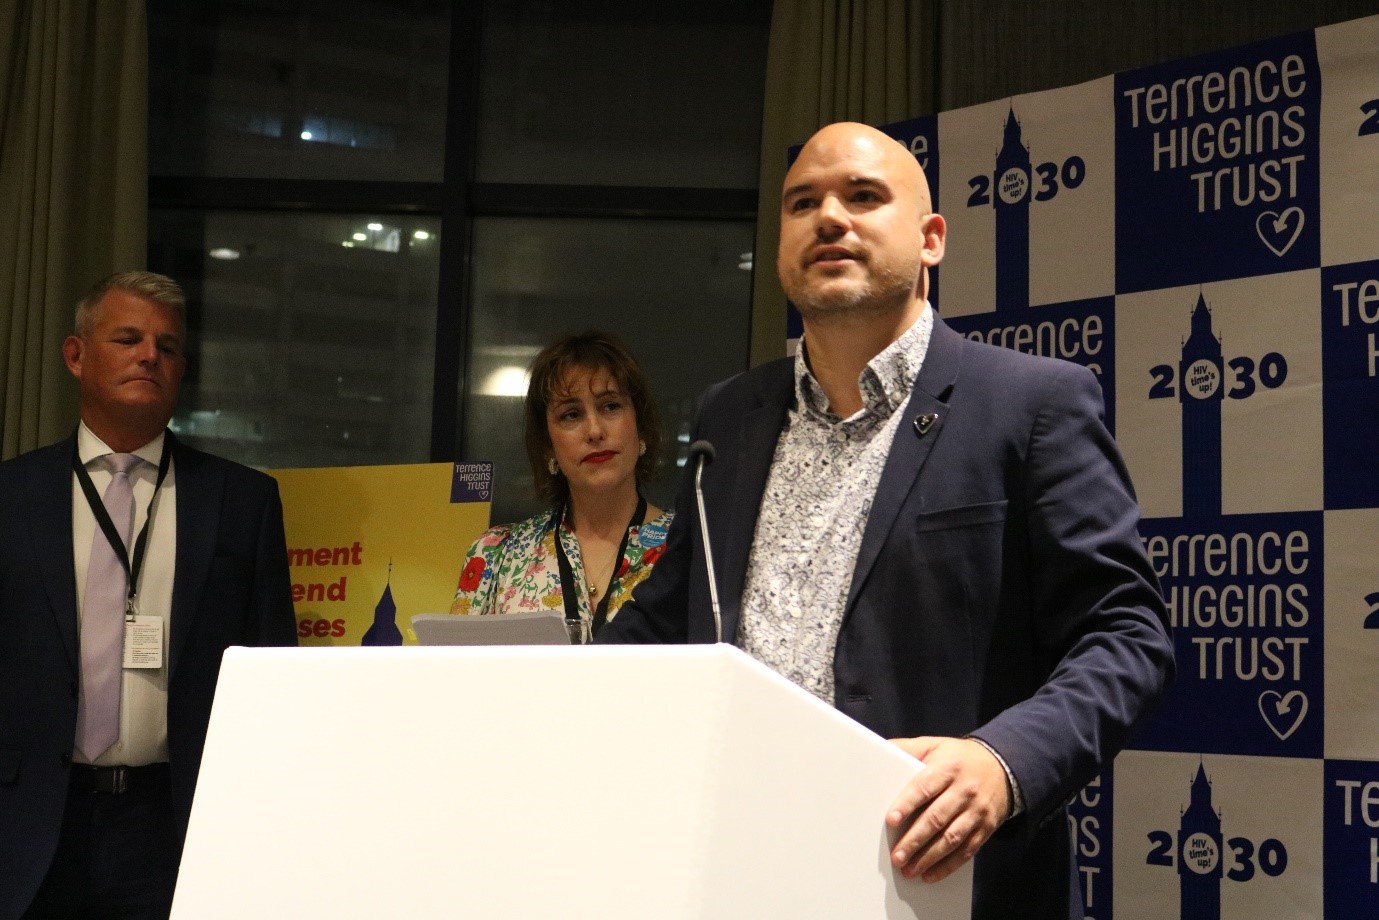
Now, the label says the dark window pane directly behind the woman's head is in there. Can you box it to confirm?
[462,218,753,523]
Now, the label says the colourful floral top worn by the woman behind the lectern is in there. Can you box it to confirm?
[450,510,674,640]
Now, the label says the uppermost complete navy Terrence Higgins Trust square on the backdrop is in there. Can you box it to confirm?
[1116,33,1321,291]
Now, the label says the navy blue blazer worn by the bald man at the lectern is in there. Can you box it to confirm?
[600,316,1174,920]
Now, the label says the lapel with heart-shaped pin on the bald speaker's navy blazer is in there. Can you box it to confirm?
[843,308,963,619]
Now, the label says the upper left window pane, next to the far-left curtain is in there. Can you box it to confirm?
[149,0,450,182]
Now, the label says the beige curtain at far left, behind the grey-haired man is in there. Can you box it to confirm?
[0,0,148,458]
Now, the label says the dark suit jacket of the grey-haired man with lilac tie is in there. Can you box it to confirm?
[0,433,296,917]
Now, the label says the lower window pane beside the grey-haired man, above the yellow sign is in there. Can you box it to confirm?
[149,211,440,468]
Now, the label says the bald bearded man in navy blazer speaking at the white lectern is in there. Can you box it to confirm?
[600,124,1174,920]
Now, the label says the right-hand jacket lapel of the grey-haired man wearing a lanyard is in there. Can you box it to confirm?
[168,432,225,677]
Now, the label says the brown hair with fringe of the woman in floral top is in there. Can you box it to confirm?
[524,330,661,508]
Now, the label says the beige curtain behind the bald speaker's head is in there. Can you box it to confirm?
[752,0,938,364]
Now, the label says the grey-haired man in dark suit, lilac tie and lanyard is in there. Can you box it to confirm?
[0,272,296,920]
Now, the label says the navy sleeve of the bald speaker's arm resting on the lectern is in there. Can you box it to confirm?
[971,364,1174,826]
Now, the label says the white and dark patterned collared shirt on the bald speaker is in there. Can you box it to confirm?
[738,308,934,706]
